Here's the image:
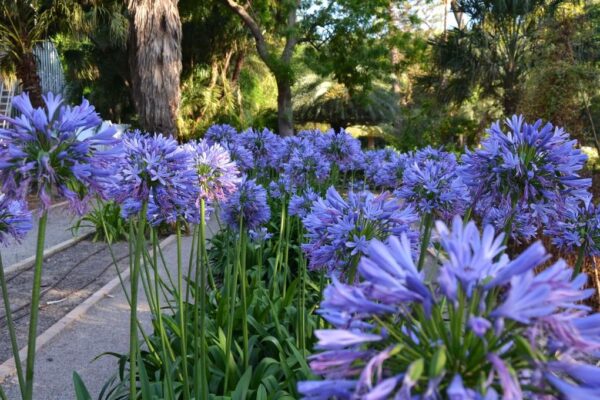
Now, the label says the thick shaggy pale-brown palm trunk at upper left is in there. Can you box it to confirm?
[128,0,182,136]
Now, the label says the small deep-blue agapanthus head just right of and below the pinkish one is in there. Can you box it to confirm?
[222,176,271,231]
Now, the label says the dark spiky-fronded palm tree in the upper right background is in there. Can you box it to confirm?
[432,0,563,115]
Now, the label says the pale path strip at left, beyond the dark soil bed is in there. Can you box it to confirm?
[0,204,93,268]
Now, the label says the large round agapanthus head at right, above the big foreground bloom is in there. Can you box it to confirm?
[461,116,591,237]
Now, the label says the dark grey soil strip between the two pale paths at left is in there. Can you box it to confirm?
[0,240,129,363]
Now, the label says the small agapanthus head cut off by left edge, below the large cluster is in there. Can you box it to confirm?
[0,194,33,245]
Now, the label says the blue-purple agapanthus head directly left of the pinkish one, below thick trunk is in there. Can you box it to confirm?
[106,131,200,224]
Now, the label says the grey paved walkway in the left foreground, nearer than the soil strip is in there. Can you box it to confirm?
[4,219,215,400]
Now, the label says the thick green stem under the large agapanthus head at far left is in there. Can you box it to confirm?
[23,211,48,400]
